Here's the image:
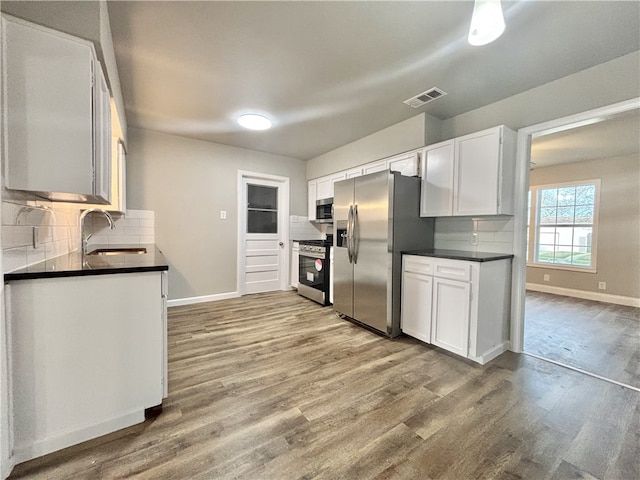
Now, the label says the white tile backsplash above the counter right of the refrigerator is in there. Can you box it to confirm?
[434,216,513,253]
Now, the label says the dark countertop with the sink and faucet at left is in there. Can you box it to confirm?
[4,244,169,282]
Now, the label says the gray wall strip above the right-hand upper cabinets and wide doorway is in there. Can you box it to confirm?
[307,52,640,179]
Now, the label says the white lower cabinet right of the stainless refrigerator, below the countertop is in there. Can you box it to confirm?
[401,255,511,364]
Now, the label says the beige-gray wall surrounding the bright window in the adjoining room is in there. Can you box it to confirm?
[527,155,640,298]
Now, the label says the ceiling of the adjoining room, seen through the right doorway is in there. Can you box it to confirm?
[531,110,640,168]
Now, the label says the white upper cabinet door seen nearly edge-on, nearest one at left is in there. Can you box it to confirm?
[93,61,112,203]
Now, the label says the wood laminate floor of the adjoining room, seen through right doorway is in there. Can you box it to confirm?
[524,292,640,388]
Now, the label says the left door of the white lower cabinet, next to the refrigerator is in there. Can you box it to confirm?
[400,272,433,343]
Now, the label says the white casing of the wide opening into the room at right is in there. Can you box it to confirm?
[510,97,640,353]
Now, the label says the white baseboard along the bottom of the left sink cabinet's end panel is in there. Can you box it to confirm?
[13,409,144,465]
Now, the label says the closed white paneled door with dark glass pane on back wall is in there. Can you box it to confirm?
[239,174,289,294]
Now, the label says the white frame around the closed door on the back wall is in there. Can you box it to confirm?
[236,170,290,295]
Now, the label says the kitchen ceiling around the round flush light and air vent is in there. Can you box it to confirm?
[109,1,640,160]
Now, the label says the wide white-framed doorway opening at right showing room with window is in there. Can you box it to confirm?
[512,99,640,390]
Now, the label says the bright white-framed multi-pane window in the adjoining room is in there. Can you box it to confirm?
[527,180,600,272]
